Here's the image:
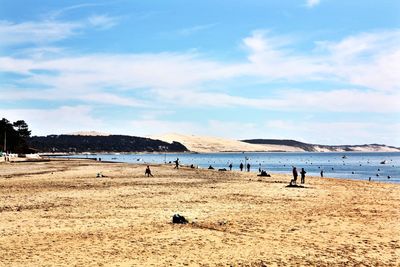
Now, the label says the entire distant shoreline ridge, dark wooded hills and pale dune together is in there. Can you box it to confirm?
[28,132,400,153]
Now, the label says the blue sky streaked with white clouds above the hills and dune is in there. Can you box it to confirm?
[0,0,400,146]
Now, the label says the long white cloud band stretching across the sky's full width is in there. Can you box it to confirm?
[0,30,400,113]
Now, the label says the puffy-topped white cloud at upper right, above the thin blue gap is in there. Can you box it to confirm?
[243,30,400,91]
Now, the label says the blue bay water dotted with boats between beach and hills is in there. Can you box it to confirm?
[60,152,400,183]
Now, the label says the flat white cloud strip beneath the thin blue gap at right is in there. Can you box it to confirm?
[158,89,400,113]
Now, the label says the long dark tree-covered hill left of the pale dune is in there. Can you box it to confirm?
[28,135,188,153]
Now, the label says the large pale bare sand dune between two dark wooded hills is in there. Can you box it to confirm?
[150,134,304,153]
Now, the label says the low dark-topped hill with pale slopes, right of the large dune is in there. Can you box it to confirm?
[242,139,400,152]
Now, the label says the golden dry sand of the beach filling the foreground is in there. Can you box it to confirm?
[0,160,400,266]
